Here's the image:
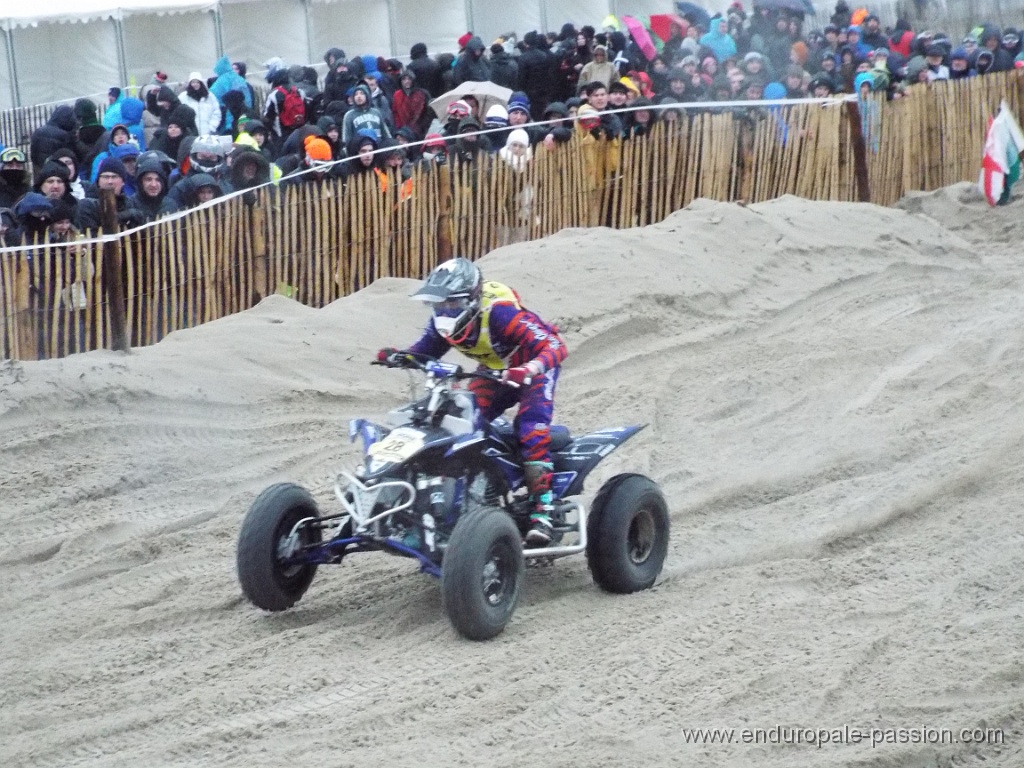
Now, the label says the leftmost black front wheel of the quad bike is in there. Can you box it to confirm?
[237,482,321,610]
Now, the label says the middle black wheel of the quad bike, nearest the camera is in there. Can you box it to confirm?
[441,507,526,640]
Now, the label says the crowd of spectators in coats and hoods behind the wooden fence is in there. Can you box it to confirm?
[0,0,1024,243]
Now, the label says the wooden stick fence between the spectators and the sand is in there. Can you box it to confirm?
[0,73,1024,359]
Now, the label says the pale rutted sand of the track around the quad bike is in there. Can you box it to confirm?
[0,184,1024,768]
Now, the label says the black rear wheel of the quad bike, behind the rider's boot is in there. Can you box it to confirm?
[587,474,669,594]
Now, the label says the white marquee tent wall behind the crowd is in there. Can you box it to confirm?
[0,0,712,109]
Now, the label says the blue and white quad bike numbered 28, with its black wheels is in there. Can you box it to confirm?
[238,354,669,640]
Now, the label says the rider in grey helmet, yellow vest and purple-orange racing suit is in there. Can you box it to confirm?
[377,258,568,547]
